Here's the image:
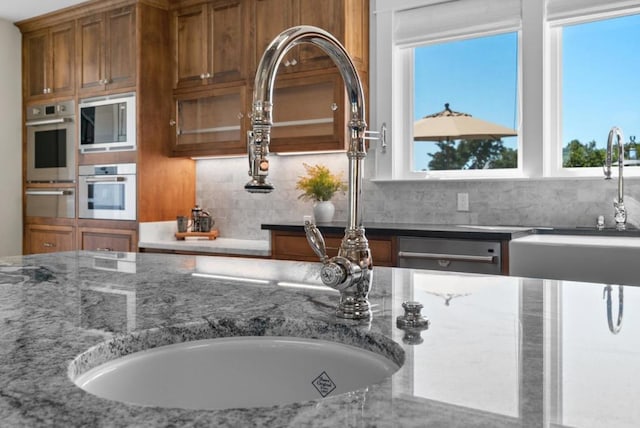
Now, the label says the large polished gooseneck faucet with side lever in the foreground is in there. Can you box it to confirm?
[245,26,373,320]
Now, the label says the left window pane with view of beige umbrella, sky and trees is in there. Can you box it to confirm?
[412,32,518,171]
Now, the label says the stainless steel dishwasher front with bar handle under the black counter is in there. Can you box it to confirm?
[398,236,502,275]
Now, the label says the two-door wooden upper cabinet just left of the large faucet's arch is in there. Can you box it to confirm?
[171,0,248,88]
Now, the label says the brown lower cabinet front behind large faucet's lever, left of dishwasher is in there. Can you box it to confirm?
[271,230,396,266]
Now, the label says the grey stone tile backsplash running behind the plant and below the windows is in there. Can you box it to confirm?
[195,153,640,239]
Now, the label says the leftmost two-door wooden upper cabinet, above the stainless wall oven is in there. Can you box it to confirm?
[23,22,75,99]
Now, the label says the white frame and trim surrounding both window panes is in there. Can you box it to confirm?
[370,0,640,181]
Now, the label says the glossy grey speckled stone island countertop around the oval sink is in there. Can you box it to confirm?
[0,252,640,427]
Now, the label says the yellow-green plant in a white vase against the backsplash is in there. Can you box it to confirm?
[296,163,347,223]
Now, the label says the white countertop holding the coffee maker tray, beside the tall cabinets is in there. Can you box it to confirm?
[138,221,271,257]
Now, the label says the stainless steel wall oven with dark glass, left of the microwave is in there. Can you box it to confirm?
[25,100,76,183]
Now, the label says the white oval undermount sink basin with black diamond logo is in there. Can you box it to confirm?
[74,336,399,410]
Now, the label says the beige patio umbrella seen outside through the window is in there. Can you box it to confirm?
[413,103,518,141]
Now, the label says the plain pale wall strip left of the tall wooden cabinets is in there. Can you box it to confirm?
[0,19,22,256]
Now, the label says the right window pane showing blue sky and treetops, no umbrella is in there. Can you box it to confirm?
[562,15,640,168]
